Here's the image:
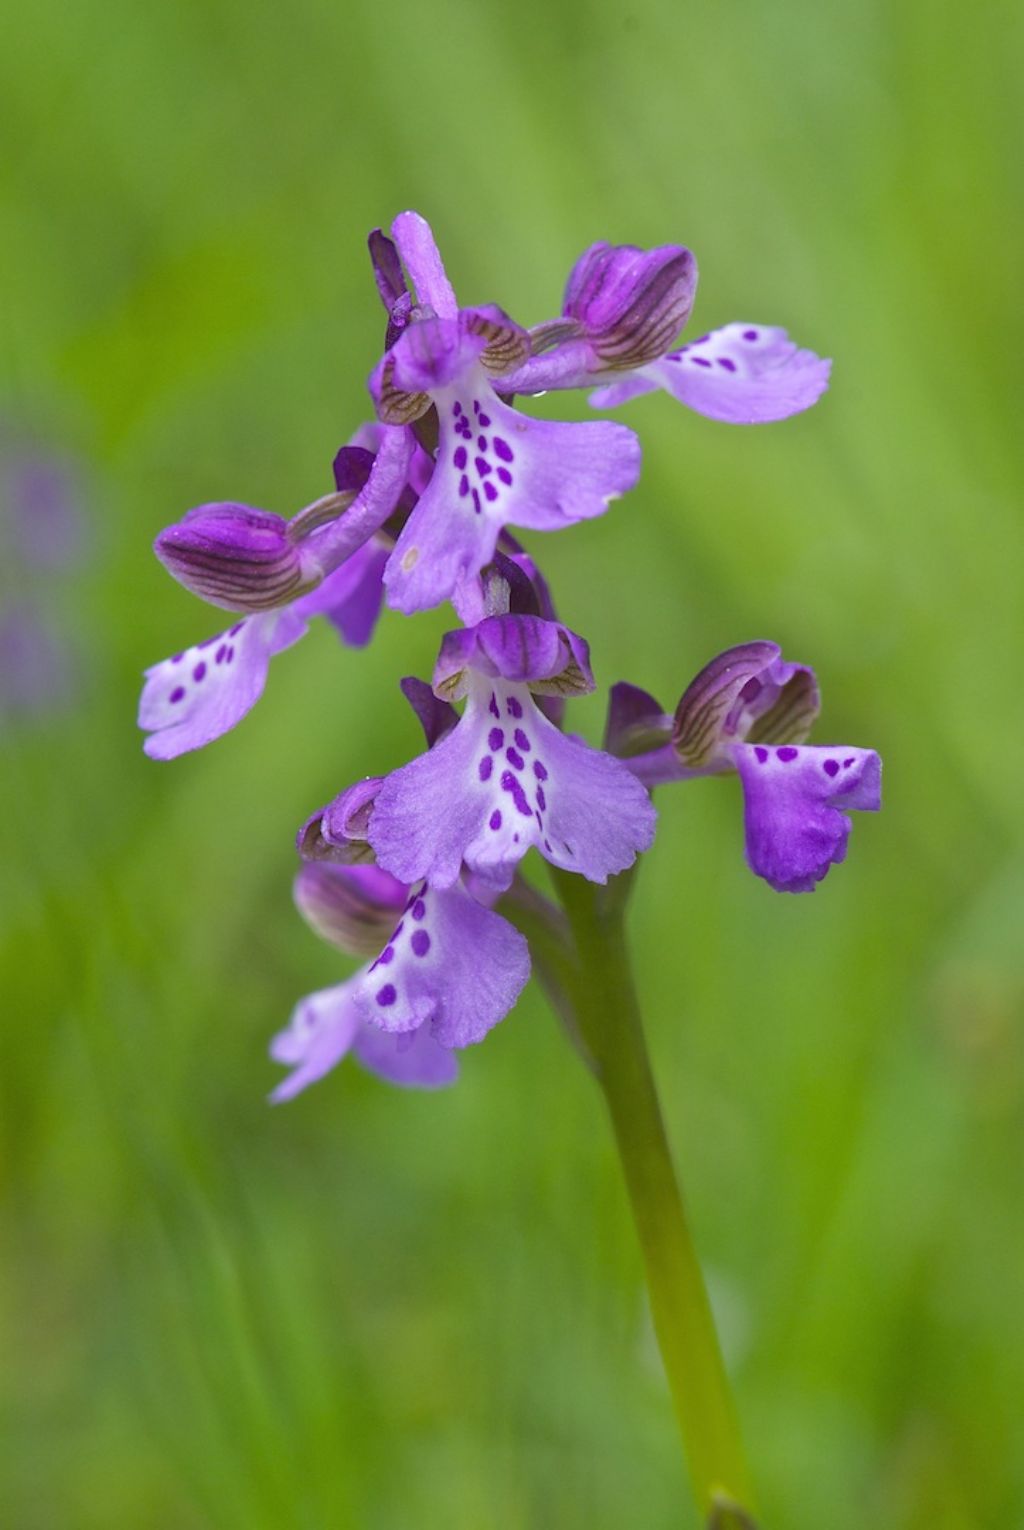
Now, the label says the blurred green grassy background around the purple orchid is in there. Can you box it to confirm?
[0,0,1024,1530]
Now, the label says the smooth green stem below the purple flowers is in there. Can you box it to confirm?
[553,871,753,1530]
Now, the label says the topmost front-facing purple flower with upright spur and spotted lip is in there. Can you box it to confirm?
[370,213,640,614]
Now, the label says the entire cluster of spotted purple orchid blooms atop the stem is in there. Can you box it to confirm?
[139,213,880,1099]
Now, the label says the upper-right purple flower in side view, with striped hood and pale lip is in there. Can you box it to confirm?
[504,243,831,425]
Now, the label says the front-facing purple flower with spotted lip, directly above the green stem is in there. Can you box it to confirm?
[367,615,655,887]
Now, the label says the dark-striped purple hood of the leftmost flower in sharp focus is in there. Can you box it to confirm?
[155,503,317,612]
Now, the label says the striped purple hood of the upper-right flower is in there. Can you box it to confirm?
[562,243,696,370]
